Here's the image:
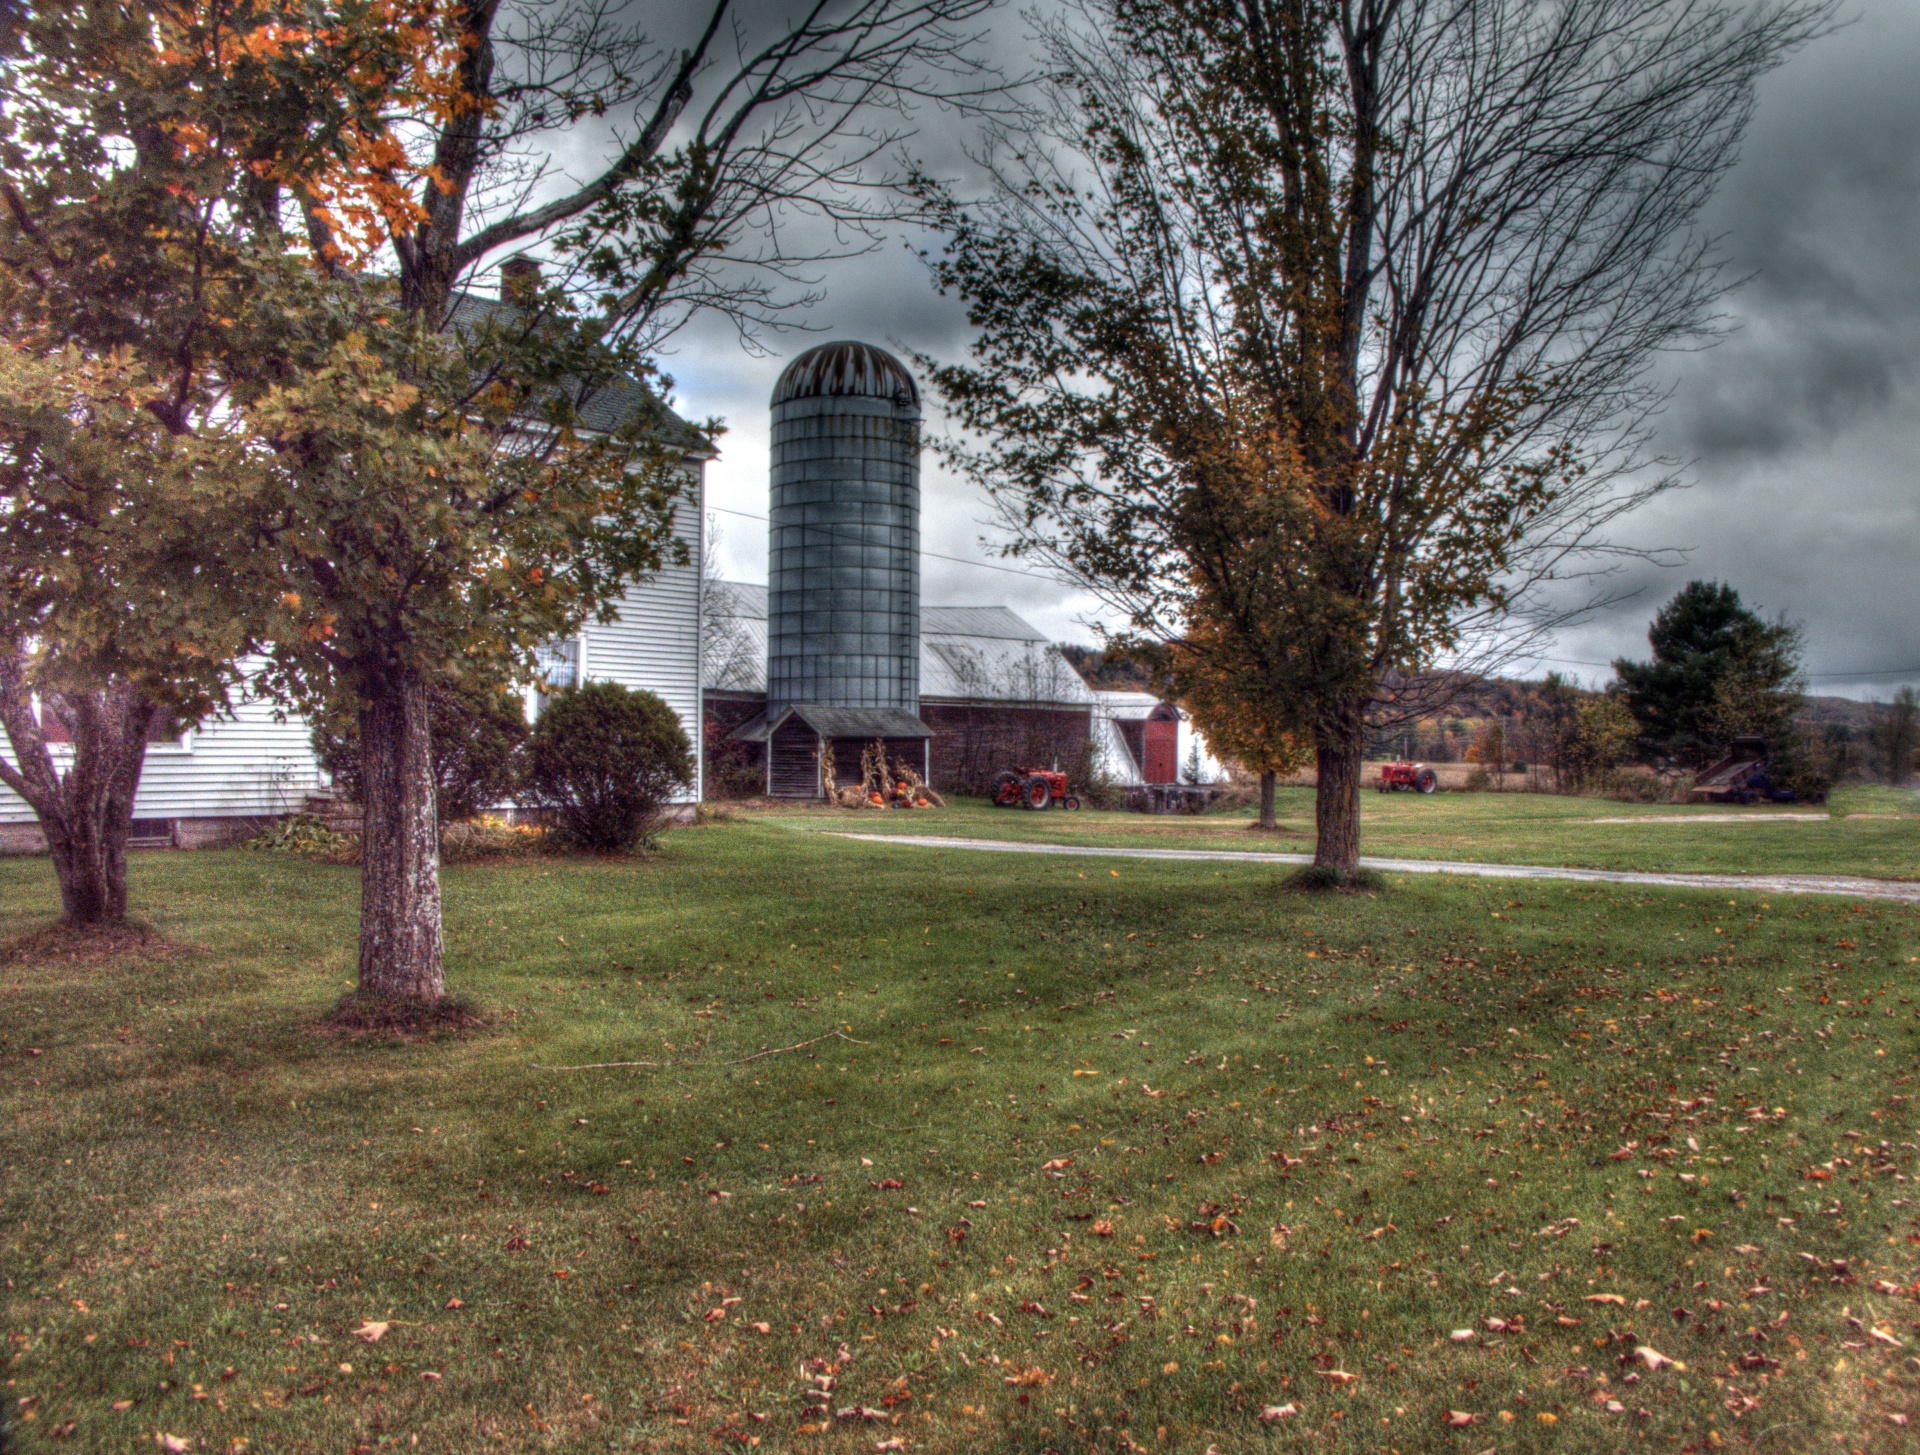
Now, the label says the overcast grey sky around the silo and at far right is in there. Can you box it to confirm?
[602,0,1920,697]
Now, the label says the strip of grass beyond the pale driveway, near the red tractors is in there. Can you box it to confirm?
[770,789,1920,879]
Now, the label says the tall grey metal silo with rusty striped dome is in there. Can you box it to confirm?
[766,344,920,720]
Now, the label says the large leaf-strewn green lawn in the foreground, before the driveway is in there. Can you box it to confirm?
[0,825,1920,1455]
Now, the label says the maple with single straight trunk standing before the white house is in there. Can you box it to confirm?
[255,0,987,1002]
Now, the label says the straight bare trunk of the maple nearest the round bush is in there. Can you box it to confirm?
[359,672,445,1004]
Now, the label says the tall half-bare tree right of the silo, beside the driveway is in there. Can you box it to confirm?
[935,0,1828,871]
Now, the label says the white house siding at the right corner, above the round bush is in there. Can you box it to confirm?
[580,466,707,800]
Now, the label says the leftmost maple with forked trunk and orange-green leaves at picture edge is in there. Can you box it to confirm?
[0,4,453,925]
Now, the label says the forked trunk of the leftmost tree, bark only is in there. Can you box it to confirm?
[0,653,156,925]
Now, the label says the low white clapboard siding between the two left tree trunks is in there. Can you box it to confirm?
[0,671,321,823]
